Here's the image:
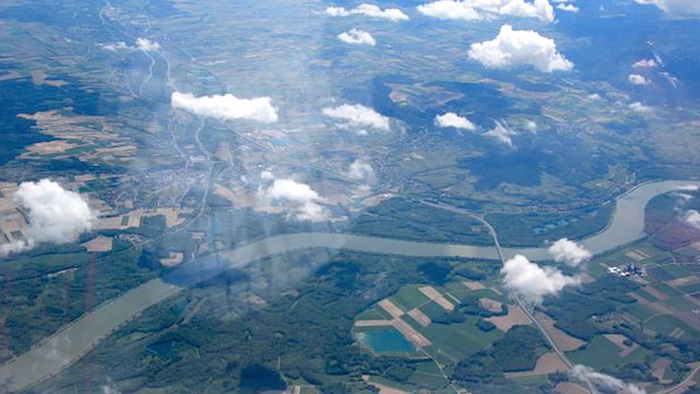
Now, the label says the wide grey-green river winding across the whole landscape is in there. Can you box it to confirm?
[0,181,700,392]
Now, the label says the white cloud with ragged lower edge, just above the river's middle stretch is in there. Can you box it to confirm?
[262,177,330,222]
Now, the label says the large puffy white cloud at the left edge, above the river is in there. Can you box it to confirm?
[0,179,97,255]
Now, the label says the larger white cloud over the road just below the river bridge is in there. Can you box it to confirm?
[501,254,581,304]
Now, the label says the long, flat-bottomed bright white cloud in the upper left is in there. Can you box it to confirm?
[170,92,277,123]
